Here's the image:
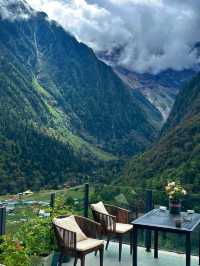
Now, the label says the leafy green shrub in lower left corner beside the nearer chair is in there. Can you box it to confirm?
[0,192,77,266]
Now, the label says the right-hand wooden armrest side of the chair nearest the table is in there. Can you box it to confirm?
[105,204,130,224]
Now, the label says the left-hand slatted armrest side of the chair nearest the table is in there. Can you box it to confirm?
[92,210,116,233]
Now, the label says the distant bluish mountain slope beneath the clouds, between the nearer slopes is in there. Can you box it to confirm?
[97,49,198,122]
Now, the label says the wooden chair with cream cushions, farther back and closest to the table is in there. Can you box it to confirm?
[91,204,133,261]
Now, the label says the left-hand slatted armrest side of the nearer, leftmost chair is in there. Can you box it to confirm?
[53,223,76,251]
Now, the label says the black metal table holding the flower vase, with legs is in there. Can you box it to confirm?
[132,209,200,266]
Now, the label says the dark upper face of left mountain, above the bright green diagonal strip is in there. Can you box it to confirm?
[1,9,159,153]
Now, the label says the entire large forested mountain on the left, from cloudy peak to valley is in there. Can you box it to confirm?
[0,0,159,192]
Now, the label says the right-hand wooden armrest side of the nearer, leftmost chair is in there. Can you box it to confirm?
[75,216,102,238]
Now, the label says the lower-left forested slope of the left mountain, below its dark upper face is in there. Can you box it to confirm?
[0,57,111,194]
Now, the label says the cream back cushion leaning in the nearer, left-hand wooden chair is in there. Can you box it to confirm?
[53,215,87,242]
